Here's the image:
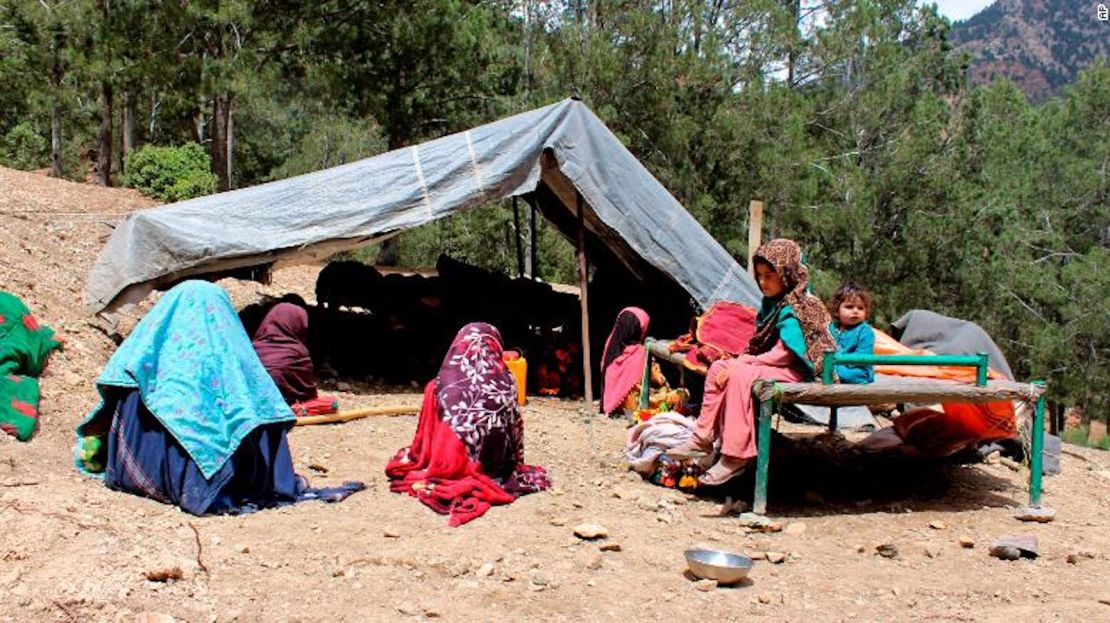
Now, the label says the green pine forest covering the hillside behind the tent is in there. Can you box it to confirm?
[0,0,1110,419]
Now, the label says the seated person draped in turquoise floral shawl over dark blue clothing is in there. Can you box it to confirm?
[77,281,362,514]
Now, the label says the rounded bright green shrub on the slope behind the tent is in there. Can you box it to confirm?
[123,143,216,201]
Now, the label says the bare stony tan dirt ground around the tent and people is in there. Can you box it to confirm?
[0,169,1110,623]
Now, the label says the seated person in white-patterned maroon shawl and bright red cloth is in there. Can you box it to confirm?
[385,322,551,526]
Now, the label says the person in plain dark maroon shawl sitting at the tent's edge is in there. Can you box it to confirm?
[251,303,317,404]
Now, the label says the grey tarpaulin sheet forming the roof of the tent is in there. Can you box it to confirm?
[85,99,759,313]
